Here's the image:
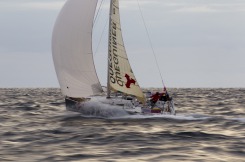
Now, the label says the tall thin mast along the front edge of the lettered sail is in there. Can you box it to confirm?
[107,0,112,98]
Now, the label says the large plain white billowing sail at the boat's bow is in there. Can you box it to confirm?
[52,0,102,97]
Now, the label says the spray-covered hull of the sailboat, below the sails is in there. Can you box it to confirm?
[66,96,175,117]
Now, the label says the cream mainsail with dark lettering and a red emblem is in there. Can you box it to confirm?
[108,0,145,102]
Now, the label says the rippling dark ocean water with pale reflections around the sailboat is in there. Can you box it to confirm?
[0,89,245,162]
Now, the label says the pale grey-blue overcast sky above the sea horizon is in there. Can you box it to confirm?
[0,0,245,88]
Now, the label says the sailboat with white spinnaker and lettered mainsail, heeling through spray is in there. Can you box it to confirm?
[52,0,175,115]
